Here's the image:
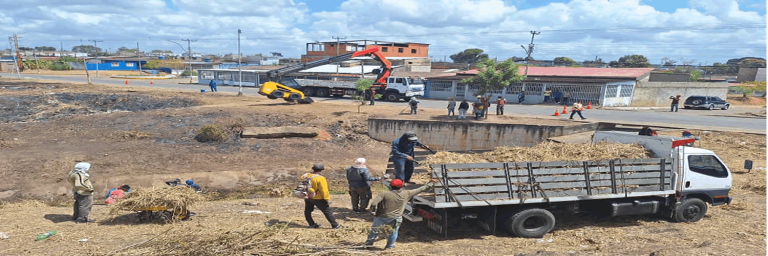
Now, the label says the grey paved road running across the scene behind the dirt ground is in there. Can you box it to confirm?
[0,73,766,134]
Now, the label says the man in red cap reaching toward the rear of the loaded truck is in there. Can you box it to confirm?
[365,179,437,249]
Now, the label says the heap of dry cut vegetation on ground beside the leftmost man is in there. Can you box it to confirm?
[110,186,205,214]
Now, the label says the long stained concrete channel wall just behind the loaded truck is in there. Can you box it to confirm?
[368,118,598,151]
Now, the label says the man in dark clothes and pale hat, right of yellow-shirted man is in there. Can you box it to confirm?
[346,157,381,212]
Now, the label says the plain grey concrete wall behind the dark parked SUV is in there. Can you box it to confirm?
[632,82,728,107]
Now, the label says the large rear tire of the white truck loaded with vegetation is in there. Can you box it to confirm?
[506,208,555,238]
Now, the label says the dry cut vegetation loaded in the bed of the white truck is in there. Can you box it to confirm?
[424,142,652,169]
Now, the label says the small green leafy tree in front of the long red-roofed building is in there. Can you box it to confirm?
[461,59,525,95]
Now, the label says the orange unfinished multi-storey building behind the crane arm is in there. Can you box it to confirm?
[301,40,429,63]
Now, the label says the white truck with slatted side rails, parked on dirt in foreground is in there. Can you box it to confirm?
[404,132,732,238]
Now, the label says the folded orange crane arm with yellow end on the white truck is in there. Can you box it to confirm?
[259,47,392,104]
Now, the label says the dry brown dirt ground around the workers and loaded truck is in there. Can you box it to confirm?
[0,80,766,255]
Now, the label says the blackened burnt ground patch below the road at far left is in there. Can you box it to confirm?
[0,93,201,123]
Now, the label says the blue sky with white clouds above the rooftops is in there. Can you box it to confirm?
[0,0,766,64]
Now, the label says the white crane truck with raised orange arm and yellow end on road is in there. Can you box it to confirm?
[259,47,424,103]
